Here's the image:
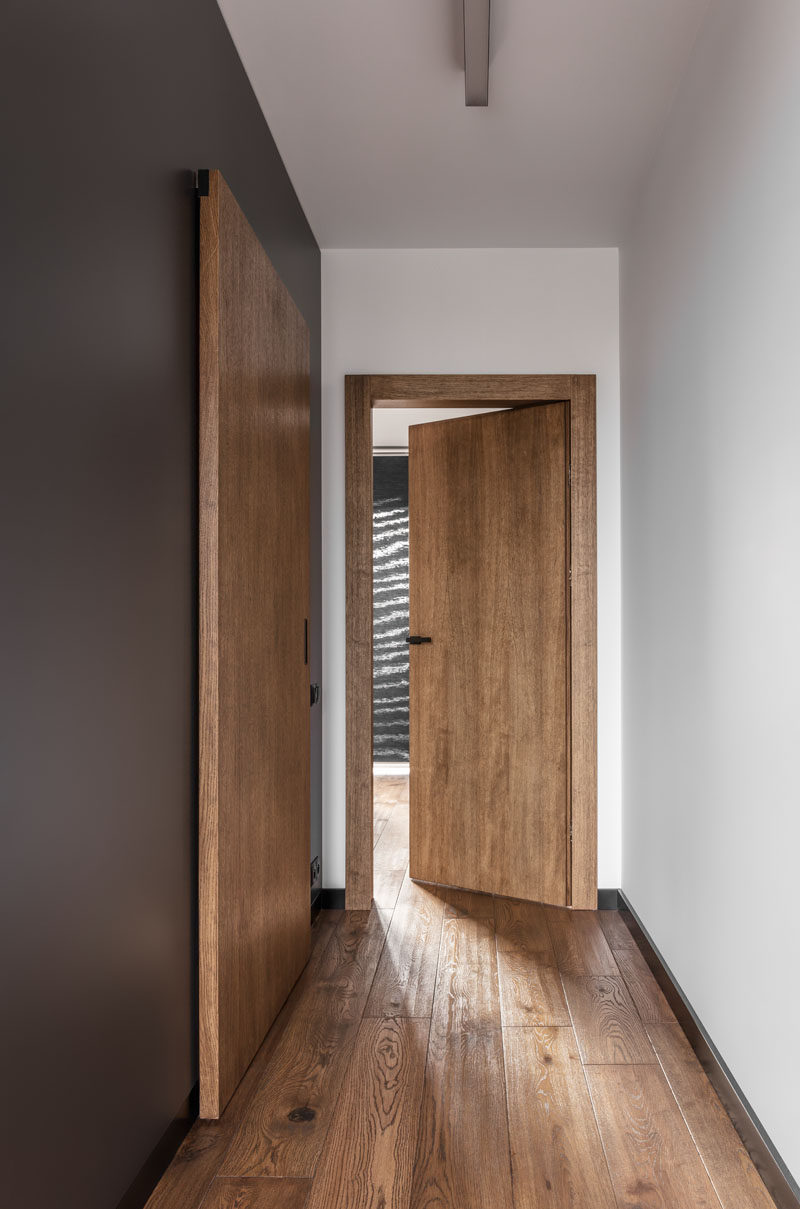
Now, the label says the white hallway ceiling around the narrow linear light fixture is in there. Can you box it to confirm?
[220,0,707,248]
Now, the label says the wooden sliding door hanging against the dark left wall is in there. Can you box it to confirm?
[199,172,309,1117]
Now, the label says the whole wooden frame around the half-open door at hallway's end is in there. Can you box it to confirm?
[344,374,597,910]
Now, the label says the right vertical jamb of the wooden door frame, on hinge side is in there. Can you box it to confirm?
[569,375,597,910]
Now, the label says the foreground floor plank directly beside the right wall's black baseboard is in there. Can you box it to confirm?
[648,1024,775,1209]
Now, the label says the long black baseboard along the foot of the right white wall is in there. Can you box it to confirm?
[616,890,800,1209]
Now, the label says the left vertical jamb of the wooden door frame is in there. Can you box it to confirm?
[344,377,372,910]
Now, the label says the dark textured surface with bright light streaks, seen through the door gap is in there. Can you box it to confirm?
[372,453,408,763]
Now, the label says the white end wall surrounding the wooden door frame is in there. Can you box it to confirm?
[323,249,620,886]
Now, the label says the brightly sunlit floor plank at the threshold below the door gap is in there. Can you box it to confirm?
[364,878,445,1017]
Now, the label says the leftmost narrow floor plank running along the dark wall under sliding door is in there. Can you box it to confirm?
[146,910,344,1209]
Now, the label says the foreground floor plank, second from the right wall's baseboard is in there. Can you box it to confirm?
[585,1065,725,1209]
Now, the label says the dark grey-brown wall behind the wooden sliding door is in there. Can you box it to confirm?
[0,0,321,1209]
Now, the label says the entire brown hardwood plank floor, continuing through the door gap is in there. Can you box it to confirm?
[149,777,773,1209]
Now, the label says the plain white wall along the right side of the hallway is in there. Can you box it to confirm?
[621,0,800,1178]
